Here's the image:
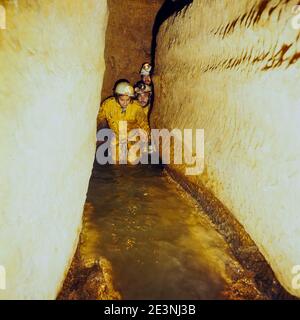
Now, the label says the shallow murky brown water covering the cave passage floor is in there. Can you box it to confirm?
[60,164,265,300]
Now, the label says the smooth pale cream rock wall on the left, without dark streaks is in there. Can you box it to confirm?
[0,0,107,299]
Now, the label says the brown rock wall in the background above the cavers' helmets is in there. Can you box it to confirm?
[102,0,164,99]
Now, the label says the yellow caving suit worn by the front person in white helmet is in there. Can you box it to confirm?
[97,97,150,161]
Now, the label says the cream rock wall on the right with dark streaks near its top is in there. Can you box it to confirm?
[151,0,300,297]
